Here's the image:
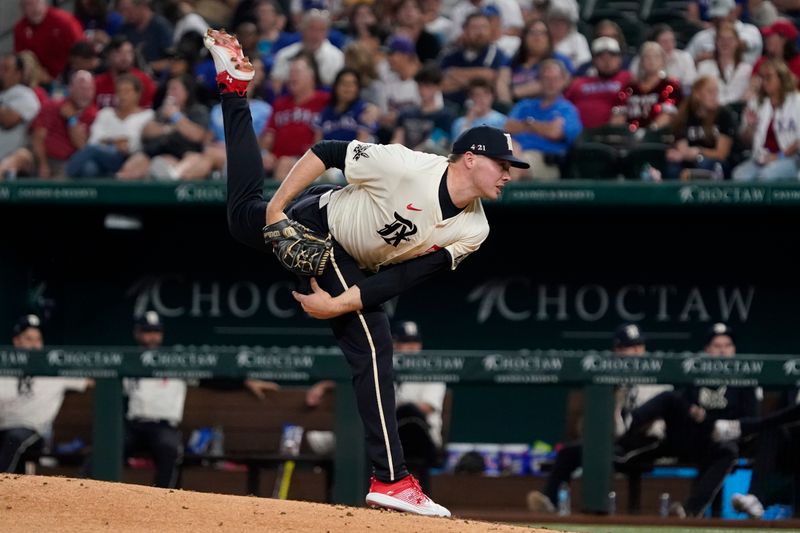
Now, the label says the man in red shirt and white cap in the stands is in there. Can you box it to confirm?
[564,37,631,129]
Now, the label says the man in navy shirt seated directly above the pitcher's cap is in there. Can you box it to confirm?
[441,12,508,106]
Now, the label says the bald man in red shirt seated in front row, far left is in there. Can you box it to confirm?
[0,70,97,178]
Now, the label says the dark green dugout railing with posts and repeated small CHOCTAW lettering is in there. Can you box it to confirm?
[0,346,800,513]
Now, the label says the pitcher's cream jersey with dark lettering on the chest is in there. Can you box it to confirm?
[321,141,489,272]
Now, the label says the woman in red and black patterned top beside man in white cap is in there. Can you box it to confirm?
[611,41,683,131]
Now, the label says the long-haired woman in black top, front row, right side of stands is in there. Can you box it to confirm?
[666,76,736,179]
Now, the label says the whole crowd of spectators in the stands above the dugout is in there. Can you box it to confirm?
[0,0,800,181]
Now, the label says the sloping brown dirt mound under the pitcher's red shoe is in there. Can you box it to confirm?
[0,474,552,533]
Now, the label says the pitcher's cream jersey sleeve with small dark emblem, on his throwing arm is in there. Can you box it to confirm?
[344,141,415,184]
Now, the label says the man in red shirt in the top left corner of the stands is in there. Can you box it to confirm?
[14,0,83,82]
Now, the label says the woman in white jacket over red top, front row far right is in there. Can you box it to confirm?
[733,59,800,181]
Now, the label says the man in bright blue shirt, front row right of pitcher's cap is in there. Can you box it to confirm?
[504,59,583,179]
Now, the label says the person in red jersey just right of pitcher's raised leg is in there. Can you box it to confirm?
[262,51,330,181]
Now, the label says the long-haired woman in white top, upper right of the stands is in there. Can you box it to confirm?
[697,21,753,105]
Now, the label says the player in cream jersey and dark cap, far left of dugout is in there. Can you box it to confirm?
[0,315,89,472]
